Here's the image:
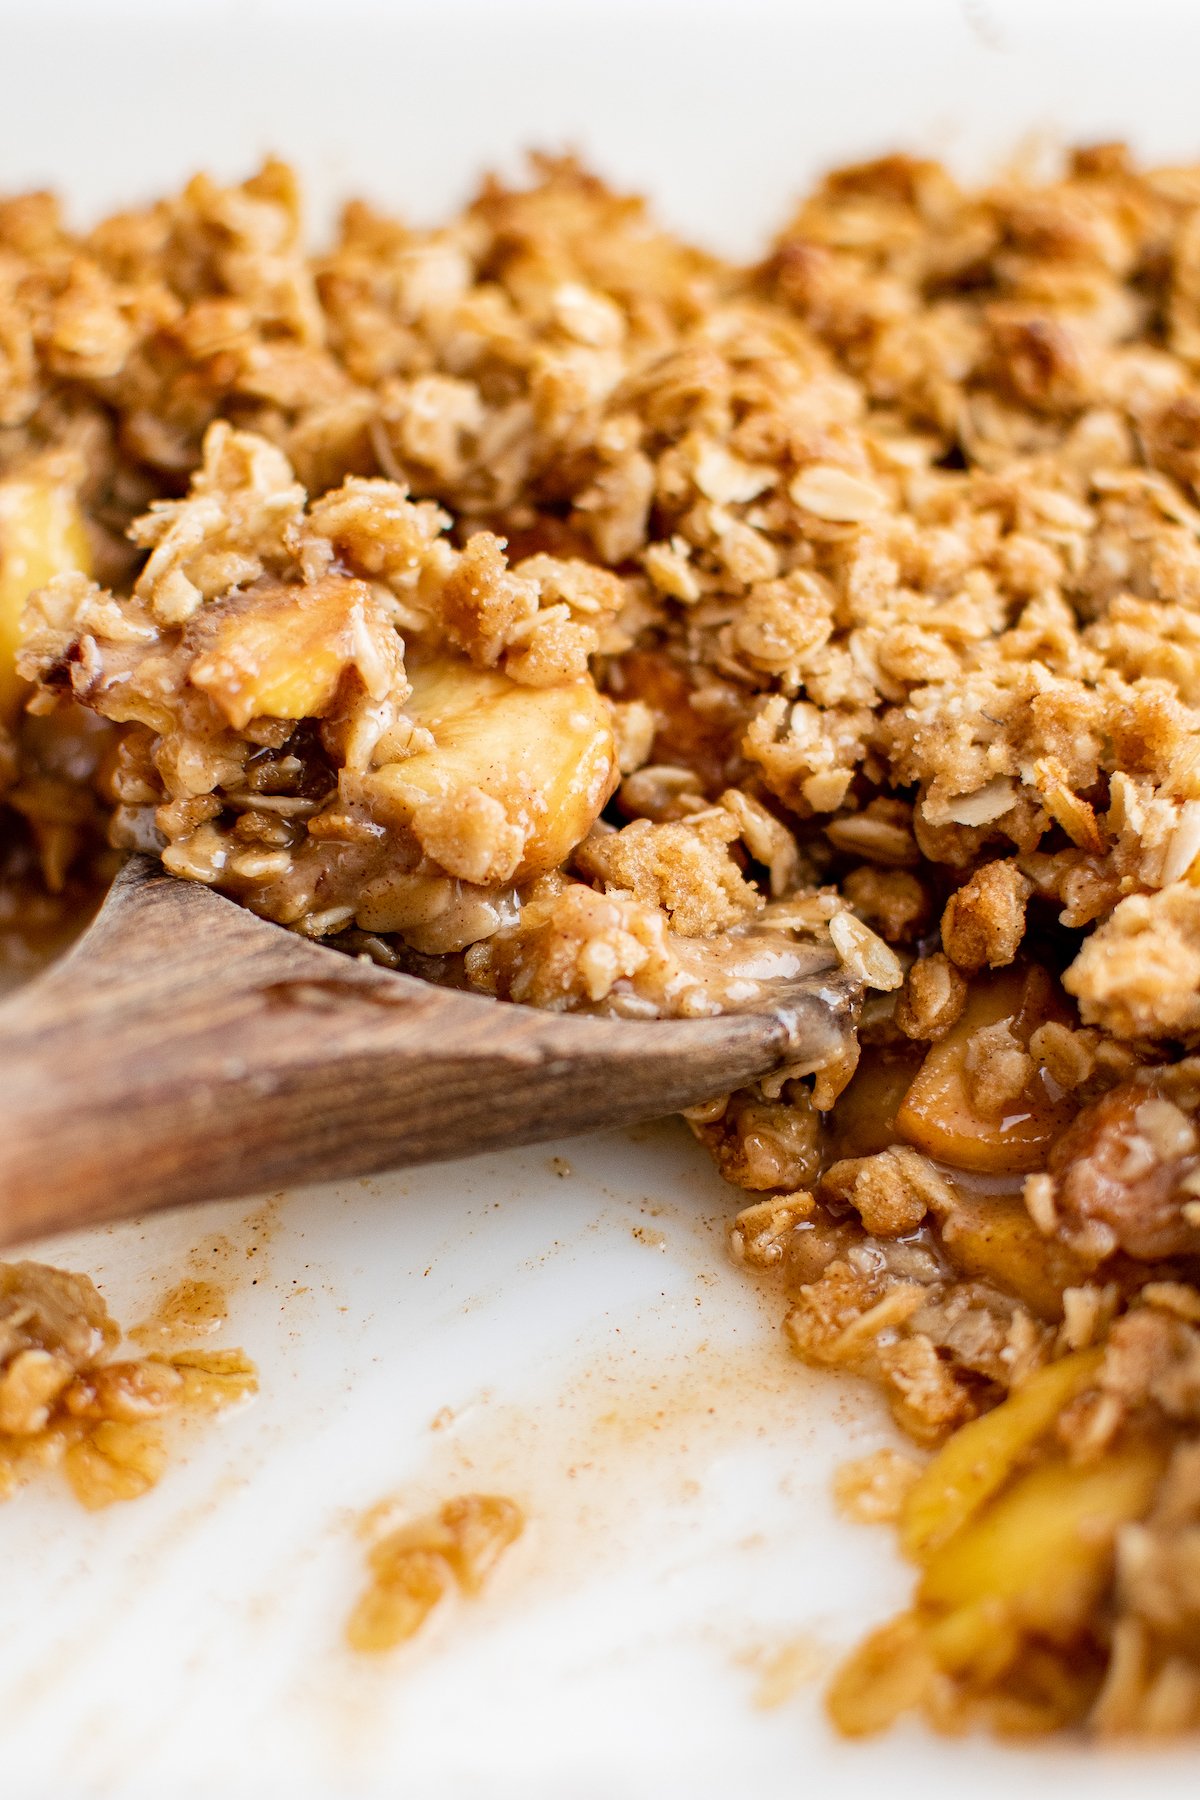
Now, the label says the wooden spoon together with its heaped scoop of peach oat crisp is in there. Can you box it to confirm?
[0,421,901,1238]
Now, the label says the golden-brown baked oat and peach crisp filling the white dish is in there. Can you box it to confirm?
[11,146,1200,1733]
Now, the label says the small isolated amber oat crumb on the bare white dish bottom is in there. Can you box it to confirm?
[345,1494,525,1654]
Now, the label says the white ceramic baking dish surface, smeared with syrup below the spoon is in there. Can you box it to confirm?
[0,0,1200,1800]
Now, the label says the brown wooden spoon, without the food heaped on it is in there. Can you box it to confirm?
[0,857,858,1242]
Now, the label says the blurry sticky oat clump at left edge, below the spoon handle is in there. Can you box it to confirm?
[0,1262,257,1508]
